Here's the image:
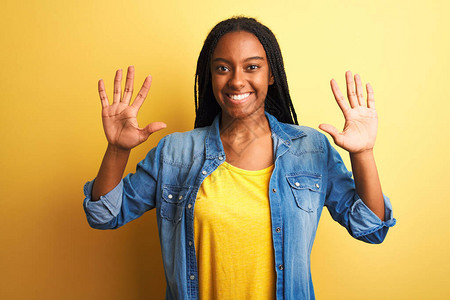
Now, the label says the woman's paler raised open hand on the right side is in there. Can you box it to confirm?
[319,71,378,153]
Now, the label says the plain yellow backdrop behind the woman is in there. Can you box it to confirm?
[0,0,450,299]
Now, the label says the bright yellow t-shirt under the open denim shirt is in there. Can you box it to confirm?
[194,162,276,300]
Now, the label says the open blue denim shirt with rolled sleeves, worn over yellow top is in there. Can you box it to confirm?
[84,113,395,299]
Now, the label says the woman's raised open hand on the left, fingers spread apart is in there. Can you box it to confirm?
[98,66,166,150]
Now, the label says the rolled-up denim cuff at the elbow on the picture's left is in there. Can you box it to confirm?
[83,180,123,227]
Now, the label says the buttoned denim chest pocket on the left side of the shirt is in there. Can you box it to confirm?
[161,185,191,224]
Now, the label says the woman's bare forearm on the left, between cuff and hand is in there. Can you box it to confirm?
[91,145,130,201]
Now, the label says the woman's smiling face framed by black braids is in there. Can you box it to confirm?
[211,31,273,120]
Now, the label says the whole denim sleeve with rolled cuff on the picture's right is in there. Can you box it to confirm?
[325,138,396,244]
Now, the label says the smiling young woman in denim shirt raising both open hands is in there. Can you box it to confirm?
[84,17,395,299]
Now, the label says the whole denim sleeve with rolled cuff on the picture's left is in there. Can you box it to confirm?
[83,139,164,229]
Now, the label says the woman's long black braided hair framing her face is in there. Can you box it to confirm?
[194,16,298,128]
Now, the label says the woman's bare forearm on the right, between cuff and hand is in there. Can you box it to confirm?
[350,150,385,221]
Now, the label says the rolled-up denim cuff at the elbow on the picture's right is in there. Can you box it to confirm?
[349,195,396,244]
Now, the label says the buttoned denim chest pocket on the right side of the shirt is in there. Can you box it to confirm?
[286,174,322,213]
